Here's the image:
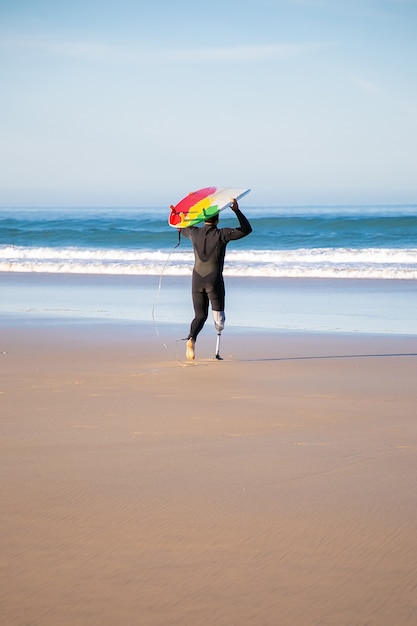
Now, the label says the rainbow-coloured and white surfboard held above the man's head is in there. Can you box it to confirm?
[168,187,250,228]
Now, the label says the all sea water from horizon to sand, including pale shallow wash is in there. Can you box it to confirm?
[0,203,417,334]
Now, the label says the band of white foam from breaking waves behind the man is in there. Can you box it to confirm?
[0,246,417,280]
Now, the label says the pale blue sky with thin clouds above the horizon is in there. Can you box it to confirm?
[0,0,417,207]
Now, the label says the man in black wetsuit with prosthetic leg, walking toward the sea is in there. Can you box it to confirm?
[181,200,252,361]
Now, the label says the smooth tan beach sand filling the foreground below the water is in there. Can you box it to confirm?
[0,321,417,626]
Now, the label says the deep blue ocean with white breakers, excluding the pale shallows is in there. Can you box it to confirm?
[0,203,417,280]
